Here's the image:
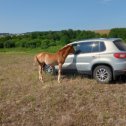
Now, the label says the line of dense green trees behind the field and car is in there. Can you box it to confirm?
[0,28,126,49]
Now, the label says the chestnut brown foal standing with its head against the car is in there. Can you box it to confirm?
[35,45,74,83]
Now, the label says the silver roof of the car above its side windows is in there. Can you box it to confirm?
[70,38,122,44]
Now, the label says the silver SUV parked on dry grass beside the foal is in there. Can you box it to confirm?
[43,38,126,83]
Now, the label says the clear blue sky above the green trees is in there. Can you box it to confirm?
[0,0,126,33]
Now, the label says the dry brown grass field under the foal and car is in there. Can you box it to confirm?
[0,53,126,126]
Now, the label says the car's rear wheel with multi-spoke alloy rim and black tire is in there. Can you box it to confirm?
[93,65,112,84]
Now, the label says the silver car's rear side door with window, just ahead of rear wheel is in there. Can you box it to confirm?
[74,42,99,73]
